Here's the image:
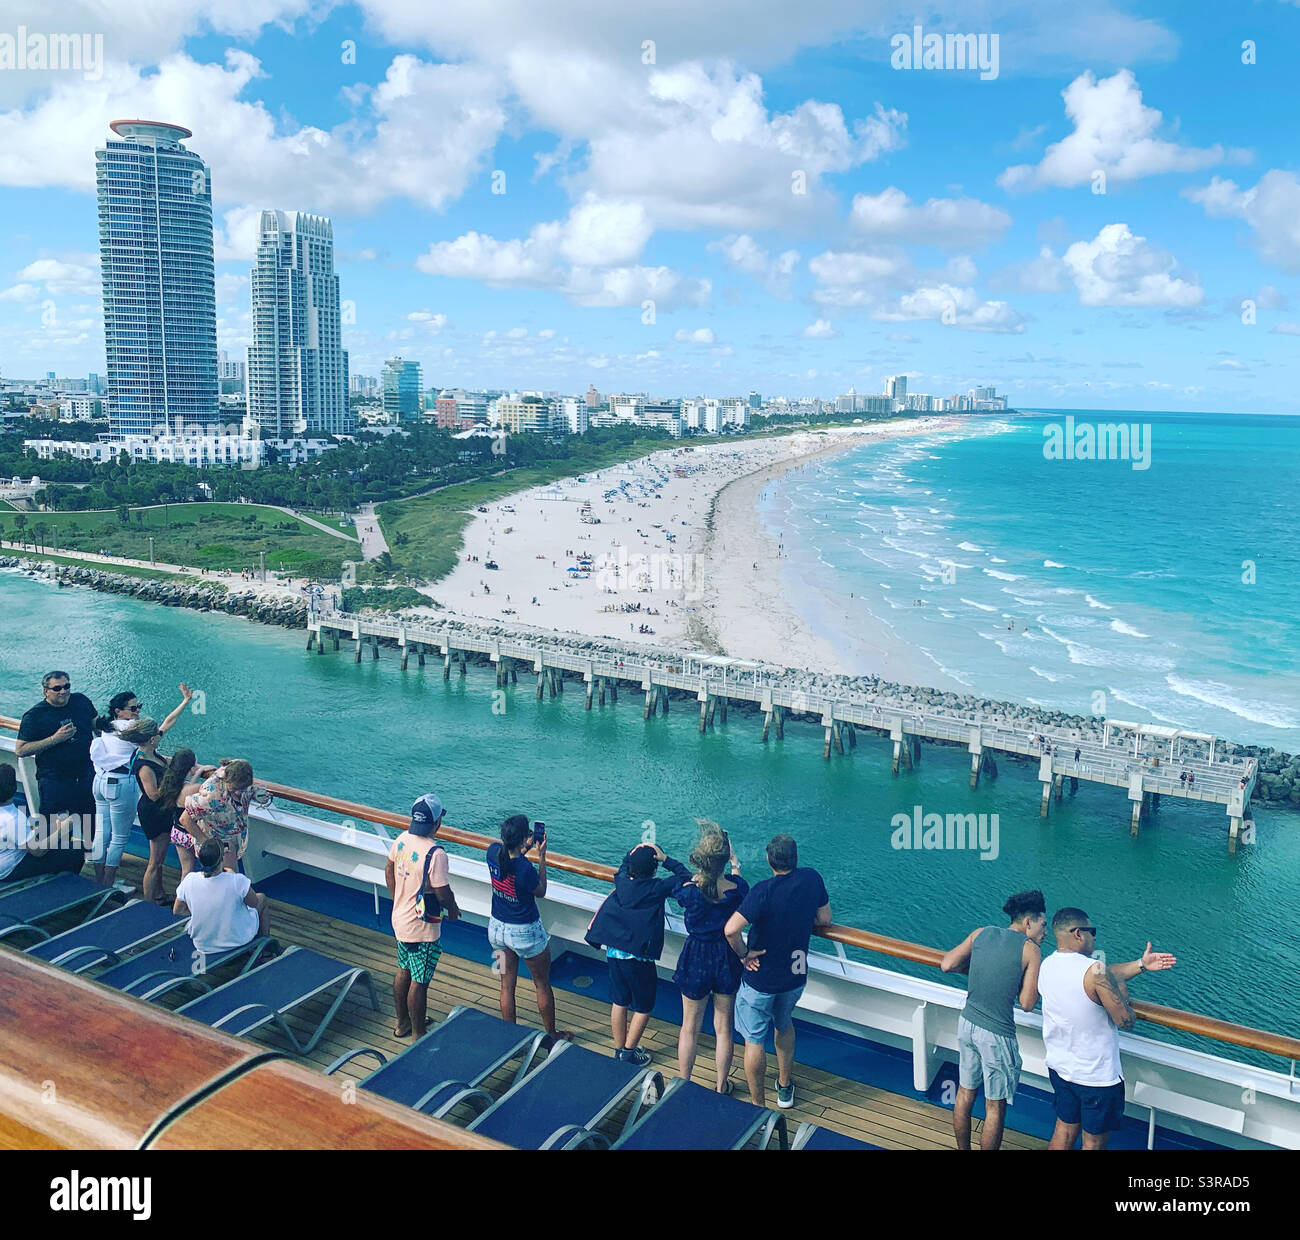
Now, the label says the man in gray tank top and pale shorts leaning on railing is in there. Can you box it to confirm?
[943,892,1048,1149]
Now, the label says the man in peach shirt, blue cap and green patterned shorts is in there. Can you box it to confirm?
[384,793,460,1037]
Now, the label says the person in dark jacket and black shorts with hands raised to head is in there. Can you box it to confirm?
[586,844,690,1067]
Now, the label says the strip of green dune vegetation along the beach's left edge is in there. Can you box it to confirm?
[374,428,676,581]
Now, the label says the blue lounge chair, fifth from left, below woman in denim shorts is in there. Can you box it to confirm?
[325,1007,549,1111]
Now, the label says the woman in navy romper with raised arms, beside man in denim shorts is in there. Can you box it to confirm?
[672,819,749,1093]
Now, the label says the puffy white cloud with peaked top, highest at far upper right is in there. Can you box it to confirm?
[997,69,1240,191]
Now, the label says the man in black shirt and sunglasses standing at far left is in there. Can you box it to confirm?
[14,672,95,868]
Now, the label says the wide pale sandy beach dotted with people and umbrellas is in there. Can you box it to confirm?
[426,417,962,673]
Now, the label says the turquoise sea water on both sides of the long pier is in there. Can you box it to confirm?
[0,415,1300,1071]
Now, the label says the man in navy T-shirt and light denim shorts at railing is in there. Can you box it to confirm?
[727,836,831,1110]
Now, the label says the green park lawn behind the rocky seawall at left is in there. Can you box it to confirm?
[0,503,358,577]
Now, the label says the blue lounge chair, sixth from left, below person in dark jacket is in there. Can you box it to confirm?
[452,1042,663,1149]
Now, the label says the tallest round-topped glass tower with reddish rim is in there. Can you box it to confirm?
[95,120,220,435]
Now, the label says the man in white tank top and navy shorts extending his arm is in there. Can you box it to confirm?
[1039,909,1177,1149]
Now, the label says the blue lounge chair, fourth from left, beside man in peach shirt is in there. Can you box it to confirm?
[177,946,380,1055]
